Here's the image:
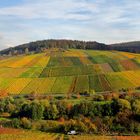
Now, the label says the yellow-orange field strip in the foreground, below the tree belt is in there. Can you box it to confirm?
[0,128,140,140]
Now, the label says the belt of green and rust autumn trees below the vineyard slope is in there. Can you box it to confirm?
[0,94,140,135]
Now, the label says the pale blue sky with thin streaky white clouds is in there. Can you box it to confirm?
[0,0,140,49]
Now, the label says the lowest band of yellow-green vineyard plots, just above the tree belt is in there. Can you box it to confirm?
[0,72,140,94]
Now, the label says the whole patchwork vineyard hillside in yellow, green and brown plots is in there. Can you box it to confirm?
[0,49,140,96]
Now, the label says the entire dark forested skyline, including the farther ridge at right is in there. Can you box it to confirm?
[0,39,140,55]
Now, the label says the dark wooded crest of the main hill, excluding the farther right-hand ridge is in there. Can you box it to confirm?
[0,39,109,55]
